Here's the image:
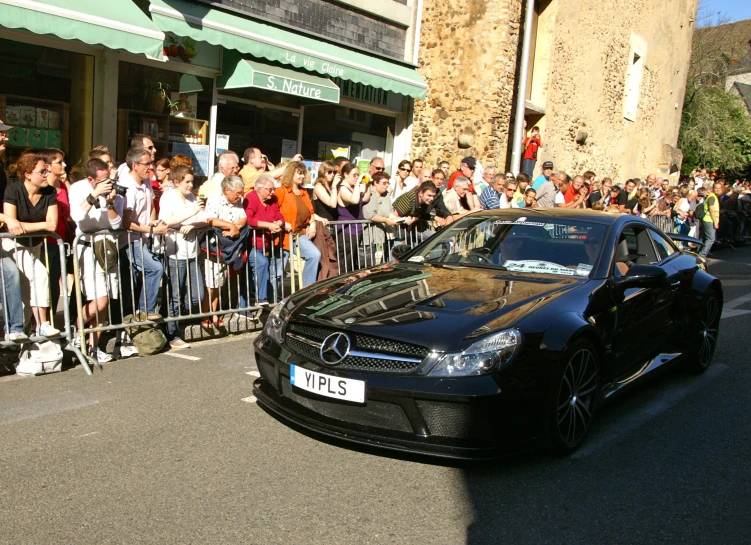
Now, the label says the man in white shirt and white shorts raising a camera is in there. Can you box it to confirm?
[69,159,123,363]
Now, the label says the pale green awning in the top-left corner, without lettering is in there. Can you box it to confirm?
[0,0,164,60]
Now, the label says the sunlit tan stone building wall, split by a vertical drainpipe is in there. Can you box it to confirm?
[412,0,698,182]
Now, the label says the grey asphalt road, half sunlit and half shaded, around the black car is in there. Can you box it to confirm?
[0,248,751,545]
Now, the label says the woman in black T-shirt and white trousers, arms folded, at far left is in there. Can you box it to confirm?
[2,153,60,337]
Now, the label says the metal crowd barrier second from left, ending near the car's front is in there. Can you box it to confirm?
[73,223,287,365]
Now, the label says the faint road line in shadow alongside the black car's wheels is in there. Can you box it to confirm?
[571,364,728,459]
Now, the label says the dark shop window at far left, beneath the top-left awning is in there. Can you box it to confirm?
[0,39,94,174]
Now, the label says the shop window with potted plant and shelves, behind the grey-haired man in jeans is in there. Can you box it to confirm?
[117,62,213,170]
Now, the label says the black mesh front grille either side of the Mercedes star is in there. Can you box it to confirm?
[285,323,429,374]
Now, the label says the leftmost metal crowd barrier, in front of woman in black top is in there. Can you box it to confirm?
[0,231,91,375]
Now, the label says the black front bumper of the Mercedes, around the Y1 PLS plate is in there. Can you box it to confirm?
[253,335,541,459]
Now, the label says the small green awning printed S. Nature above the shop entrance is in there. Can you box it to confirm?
[216,51,339,104]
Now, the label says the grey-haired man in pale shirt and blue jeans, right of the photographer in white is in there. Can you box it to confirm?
[119,148,167,320]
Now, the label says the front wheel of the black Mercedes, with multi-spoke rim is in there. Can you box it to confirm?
[545,339,600,456]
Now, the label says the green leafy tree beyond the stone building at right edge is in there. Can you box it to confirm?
[678,5,751,176]
